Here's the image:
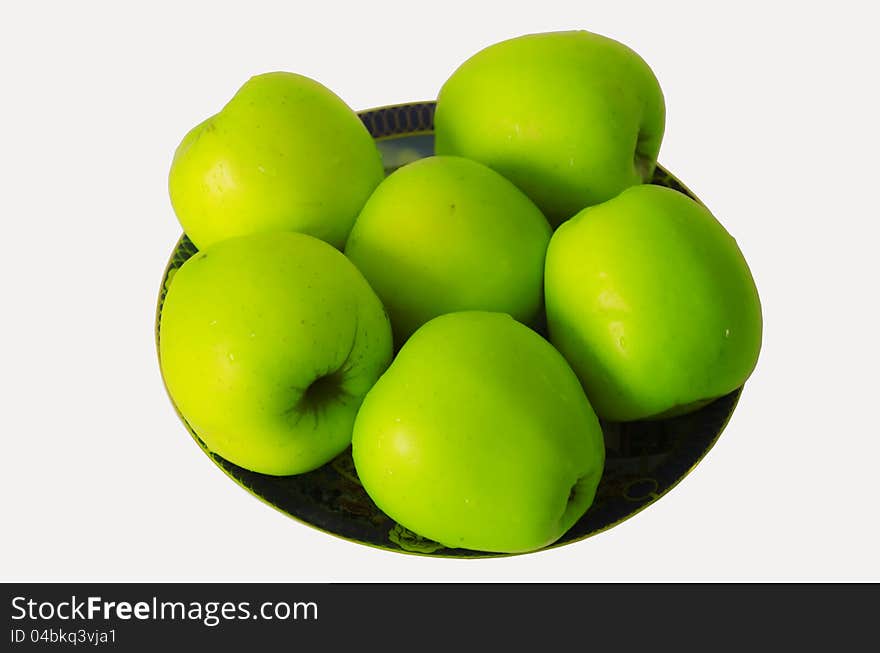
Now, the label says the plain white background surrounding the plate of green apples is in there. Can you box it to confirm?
[0,0,880,581]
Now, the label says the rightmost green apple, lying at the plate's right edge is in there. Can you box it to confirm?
[545,185,762,421]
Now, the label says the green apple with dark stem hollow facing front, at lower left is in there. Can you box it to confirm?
[159,232,391,476]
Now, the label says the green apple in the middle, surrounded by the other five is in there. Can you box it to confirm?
[345,156,551,343]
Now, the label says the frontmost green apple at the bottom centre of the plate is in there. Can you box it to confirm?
[352,311,605,553]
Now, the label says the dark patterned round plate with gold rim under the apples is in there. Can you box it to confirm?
[156,102,740,558]
